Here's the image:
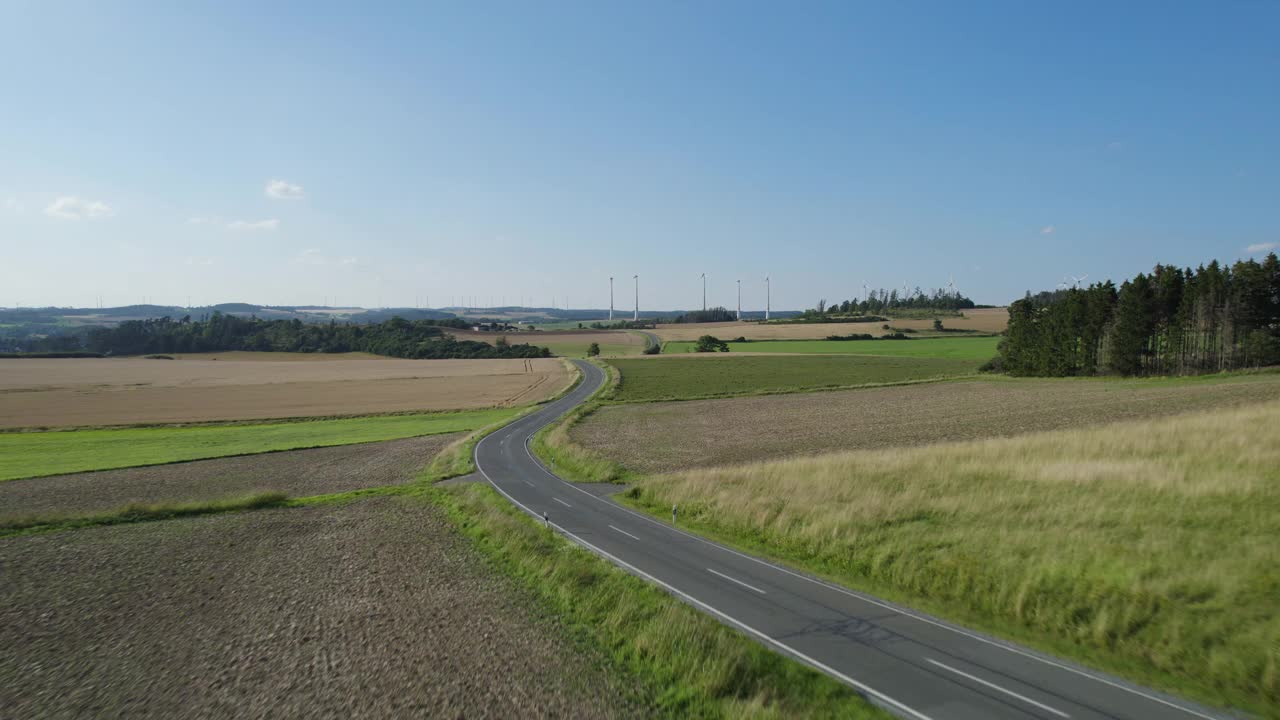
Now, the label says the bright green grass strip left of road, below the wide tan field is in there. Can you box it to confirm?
[0,409,520,480]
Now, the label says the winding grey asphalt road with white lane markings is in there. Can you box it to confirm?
[476,360,1226,720]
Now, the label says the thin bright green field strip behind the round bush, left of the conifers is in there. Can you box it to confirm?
[663,337,1000,363]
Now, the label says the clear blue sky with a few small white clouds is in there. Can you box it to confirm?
[0,0,1280,310]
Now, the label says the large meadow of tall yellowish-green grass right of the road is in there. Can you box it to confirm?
[623,401,1280,717]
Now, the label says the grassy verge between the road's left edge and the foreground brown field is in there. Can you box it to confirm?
[419,484,890,719]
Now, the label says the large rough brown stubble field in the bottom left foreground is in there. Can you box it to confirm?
[0,498,643,719]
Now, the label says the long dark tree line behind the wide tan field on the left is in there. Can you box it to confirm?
[31,313,550,359]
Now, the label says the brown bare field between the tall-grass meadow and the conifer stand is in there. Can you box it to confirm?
[570,374,1280,473]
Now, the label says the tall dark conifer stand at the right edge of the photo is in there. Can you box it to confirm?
[1000,252,1280,377]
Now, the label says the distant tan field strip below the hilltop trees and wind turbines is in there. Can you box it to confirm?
[649,307,1009,341]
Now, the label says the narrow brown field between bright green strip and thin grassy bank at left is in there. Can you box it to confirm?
[0,433,465,523]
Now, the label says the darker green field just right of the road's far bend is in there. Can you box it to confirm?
[609,353,986,401]
